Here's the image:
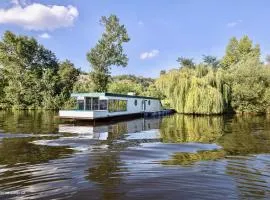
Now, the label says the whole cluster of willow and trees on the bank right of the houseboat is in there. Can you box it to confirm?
[156,36,270,114]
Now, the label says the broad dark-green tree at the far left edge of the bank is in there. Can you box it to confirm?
[0,31,58,108]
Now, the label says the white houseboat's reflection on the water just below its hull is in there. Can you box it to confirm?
[58,118,161,141]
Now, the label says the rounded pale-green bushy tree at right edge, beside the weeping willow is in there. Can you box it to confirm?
[225,56,270,113]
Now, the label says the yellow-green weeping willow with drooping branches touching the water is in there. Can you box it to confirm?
[156,64,230,115]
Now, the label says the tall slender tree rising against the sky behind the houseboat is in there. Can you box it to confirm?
[87,15,130,92]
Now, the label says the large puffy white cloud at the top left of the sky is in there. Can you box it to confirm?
[0,0,79,31]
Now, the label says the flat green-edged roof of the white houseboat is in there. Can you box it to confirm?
[71,92,159,100]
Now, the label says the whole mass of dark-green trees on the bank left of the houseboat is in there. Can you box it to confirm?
[0,31,79,109]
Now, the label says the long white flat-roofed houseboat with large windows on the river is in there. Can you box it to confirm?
[59,93,163,120]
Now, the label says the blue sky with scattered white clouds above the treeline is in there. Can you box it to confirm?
[0,0,270,78]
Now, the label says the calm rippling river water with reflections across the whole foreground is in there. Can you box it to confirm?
[0,112,270,200]
